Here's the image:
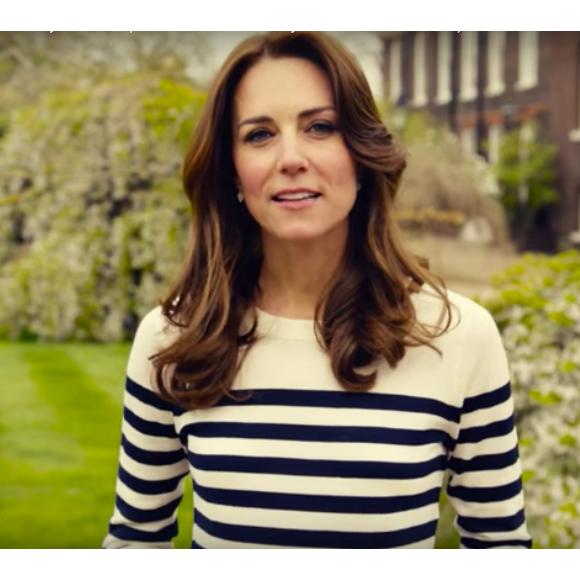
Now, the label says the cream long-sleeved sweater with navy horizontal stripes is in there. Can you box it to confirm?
[103,290,531,549]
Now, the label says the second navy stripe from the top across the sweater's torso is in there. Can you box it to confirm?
[183,422,451,447]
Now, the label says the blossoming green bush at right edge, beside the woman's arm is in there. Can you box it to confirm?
[484,251,580,549]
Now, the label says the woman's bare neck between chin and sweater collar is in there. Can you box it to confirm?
[257,227,346,320]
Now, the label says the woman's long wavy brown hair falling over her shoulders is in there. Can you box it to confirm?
[152,31,451,409]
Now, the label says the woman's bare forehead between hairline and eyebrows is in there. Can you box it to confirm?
[234,58,334,121]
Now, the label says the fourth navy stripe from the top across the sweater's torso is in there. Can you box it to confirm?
[195,484,440,514]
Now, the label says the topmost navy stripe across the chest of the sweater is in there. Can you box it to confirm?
[217,389,461,423]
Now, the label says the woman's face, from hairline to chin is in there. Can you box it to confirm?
[233,58,357,247]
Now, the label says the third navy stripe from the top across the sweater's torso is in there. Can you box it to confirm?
[189,453,447,480]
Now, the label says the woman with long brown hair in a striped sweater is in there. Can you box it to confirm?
[104,32,530,549]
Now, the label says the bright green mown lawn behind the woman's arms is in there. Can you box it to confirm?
[0,344,457,549]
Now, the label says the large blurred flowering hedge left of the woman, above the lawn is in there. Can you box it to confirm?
[0,72,205,340]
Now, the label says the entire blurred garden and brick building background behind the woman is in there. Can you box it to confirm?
[0,31,580,549]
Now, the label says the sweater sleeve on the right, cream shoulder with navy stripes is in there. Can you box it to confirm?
[447,303,532,550]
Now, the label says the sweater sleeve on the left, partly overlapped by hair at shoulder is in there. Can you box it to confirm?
[102,308,189,550]
